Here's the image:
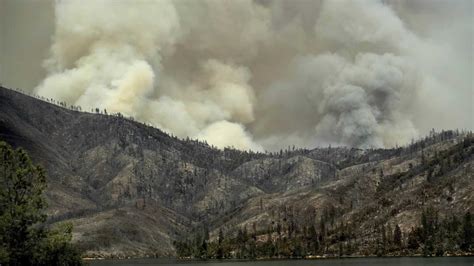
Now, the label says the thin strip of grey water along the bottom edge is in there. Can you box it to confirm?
[90,257,474,266]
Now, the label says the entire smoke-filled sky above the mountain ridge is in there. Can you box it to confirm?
[0,0,474,150]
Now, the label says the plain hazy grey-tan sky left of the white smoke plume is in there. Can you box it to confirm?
[0,0,54,90]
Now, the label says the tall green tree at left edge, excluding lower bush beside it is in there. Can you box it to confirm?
[0,142,46,265]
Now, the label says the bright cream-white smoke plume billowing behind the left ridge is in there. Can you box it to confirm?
[37,0,261,150]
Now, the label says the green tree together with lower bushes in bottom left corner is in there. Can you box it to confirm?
[0,142,82,265]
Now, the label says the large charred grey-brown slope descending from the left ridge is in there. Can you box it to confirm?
[0,88,333,255]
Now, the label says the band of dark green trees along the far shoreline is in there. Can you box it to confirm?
[175,208,474,259]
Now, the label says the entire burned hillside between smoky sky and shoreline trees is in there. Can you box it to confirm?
[0,88,474,256]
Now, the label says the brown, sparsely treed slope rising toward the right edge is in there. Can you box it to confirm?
[214,139,474,252]
